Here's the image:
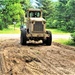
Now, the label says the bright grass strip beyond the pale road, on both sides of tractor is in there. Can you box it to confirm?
[0,24,70,34]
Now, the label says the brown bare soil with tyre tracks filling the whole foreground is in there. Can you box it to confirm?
[0,39,75,75]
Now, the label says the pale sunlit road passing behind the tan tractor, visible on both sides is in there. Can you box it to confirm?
[0,34,71,40]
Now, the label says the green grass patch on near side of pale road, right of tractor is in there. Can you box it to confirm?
[54,39,75,46]
